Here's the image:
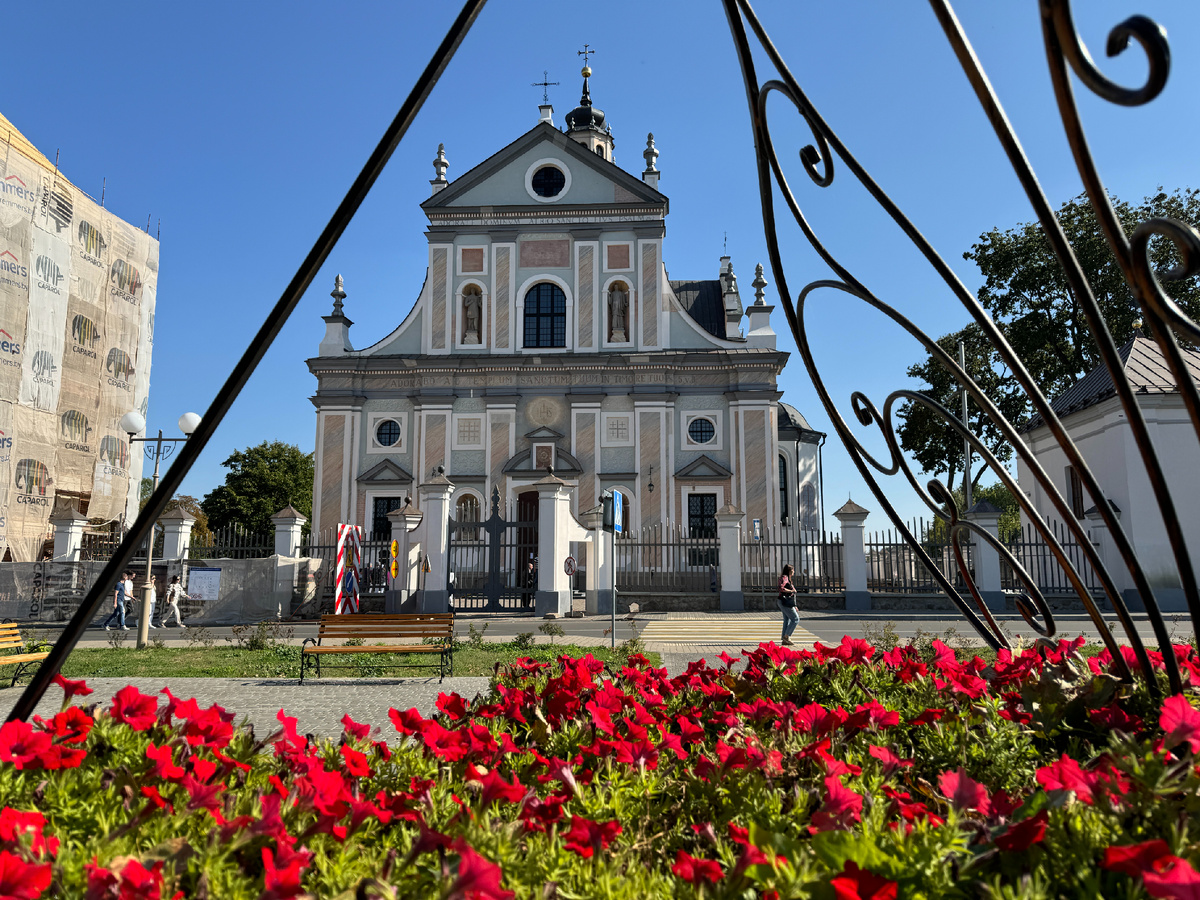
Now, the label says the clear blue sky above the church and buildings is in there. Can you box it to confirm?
[0,0,1200,527]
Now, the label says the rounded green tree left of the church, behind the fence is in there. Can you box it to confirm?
[200,440,313,533]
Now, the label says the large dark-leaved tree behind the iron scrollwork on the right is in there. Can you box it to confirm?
[896,188,1200,484]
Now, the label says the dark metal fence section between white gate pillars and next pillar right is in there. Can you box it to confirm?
[613,522,721,594]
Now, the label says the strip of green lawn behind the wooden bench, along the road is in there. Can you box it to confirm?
[62,643,661,678]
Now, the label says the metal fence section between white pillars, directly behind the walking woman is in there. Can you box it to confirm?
[742,526,846,607]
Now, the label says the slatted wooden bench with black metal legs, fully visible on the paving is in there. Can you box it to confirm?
[300,612,454,684]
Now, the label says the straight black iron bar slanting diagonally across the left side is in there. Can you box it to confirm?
[8,0,486,721]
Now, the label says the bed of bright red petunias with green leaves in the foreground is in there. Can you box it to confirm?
[0,638,1200,900]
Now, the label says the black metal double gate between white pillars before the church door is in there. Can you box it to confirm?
[449,488,538,612]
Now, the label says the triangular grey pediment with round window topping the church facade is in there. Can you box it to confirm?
[421,122,667,216]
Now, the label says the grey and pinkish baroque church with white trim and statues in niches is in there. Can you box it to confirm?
[307,67,824,549]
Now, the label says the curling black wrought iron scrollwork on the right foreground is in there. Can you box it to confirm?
[722,0,1200,692]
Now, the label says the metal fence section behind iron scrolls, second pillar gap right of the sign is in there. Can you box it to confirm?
[863,518,974,594]
